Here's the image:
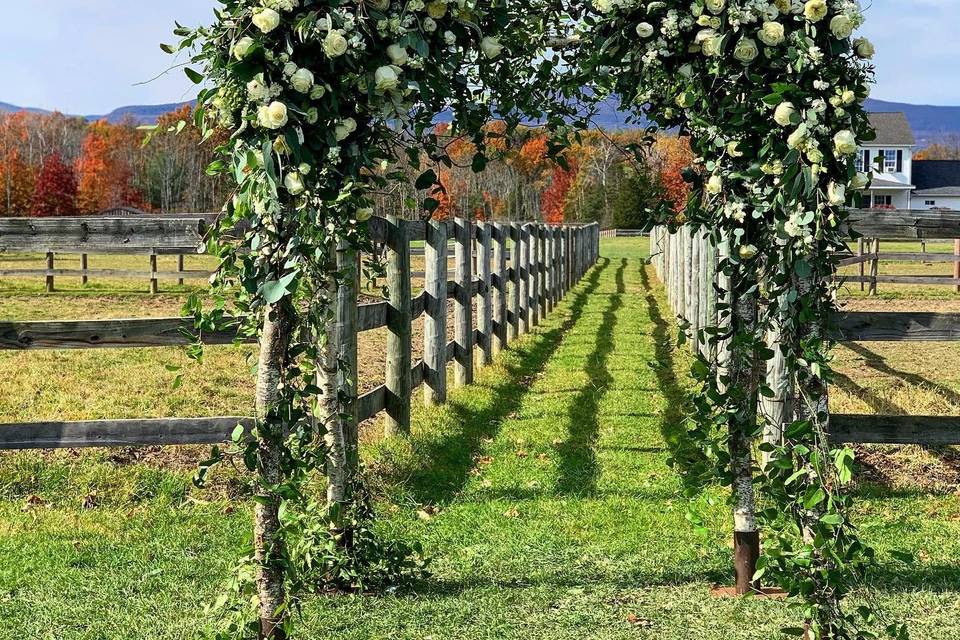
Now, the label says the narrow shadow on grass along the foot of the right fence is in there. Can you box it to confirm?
[640,266,707,489]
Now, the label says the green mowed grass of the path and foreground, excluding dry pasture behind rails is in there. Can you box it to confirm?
[0,239,960,640]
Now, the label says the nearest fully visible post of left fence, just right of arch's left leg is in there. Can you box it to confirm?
[385,215,412,436]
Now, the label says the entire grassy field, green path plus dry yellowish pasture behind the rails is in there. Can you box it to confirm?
[0,239,960,640]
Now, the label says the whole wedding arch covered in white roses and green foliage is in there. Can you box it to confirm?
[172,0,884,638]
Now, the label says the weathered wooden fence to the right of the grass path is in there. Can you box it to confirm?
[651,210,960,445]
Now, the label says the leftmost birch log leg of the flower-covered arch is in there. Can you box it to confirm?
[253,301,294,640]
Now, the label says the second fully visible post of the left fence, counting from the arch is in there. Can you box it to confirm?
[423,220,447,405]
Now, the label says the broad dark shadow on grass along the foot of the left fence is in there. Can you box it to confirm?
[391,258,610,504]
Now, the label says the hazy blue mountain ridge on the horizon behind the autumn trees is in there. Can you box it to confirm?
[0,98,960,147]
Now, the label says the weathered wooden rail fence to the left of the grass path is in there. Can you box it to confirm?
[0,215,600,449]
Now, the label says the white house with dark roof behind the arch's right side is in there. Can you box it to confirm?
[856,112,960,210]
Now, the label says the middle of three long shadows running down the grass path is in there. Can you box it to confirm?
[557,258,627,495]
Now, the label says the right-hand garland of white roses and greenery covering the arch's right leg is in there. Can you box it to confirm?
[581,0,906,638]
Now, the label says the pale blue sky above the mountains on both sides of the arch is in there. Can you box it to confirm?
[0,0,960,114]
